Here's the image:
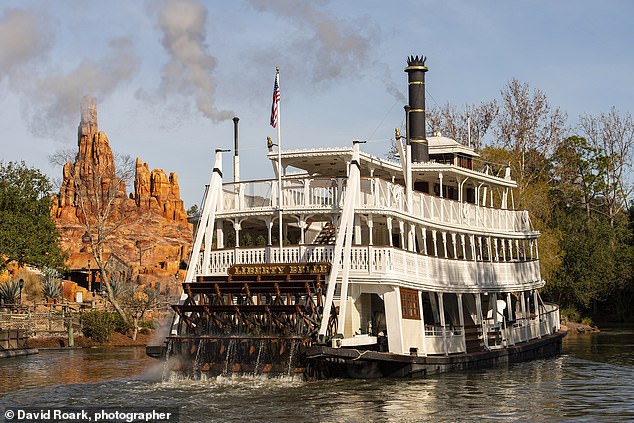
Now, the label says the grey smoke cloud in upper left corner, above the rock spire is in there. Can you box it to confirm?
[0,9,138,137]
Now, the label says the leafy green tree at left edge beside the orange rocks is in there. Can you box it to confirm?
[0,161,63,270]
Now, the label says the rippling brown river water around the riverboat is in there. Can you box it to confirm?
[0,326,634,422]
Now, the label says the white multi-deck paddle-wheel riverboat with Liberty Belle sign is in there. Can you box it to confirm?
[147,57,565,378]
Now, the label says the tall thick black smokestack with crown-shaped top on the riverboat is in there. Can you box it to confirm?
[405,56,429,163]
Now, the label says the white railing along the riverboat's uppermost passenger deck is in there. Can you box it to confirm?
[222,178,531,232]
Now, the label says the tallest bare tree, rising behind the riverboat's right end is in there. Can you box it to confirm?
[495,79,566,196]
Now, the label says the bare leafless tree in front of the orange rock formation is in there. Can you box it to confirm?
[50,148,136,324]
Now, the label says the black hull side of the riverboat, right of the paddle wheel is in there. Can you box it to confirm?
[305,331,566,379]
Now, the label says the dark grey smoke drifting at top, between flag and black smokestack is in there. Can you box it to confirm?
[244,0,376,83]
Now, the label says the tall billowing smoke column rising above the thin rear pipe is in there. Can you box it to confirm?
[137,0,234,122]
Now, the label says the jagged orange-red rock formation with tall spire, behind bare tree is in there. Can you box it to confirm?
[51,97,192,288]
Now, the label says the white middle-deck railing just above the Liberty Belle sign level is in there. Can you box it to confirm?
[196,245,541,292]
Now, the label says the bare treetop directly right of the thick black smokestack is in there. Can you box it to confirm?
[426,100,500,150]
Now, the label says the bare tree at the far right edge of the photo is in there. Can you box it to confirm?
[579,107,634,227]
